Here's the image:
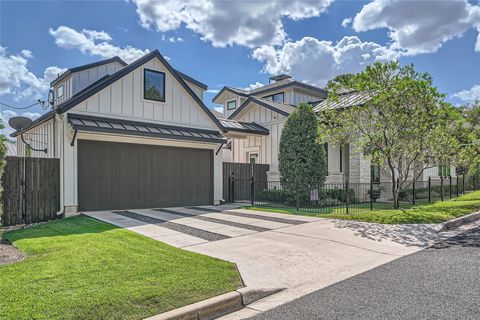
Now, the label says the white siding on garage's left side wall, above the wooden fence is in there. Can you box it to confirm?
[17,119,55,158]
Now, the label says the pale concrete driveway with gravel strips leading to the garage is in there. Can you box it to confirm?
[85,206,439,319]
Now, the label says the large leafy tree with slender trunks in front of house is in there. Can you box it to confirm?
[319,62,461,208]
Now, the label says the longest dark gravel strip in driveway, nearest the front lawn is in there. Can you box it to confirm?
[112,210,230,241]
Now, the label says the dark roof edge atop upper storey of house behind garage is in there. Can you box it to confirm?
[212,78,327,102]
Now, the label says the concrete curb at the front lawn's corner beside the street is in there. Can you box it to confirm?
[145,287,283,320]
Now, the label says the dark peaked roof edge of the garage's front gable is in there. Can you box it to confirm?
[53,50,225,131]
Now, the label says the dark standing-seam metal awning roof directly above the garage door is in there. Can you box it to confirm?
[68,113,227,143]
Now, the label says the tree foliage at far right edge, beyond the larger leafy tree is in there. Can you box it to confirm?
[458,101,480,175]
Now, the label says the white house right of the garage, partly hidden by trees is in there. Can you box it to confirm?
[212,74,455,184]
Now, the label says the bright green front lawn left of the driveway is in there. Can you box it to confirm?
[0,217,241,319]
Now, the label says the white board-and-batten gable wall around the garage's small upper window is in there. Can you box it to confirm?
[70,58,218,130]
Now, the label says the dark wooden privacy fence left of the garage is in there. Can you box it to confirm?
[0,157,60,227]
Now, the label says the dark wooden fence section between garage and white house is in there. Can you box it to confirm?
[223,162,270,202]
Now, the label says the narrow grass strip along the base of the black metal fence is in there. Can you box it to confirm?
[247,191,480,224]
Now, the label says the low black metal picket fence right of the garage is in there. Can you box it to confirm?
[228,176,480,214]
